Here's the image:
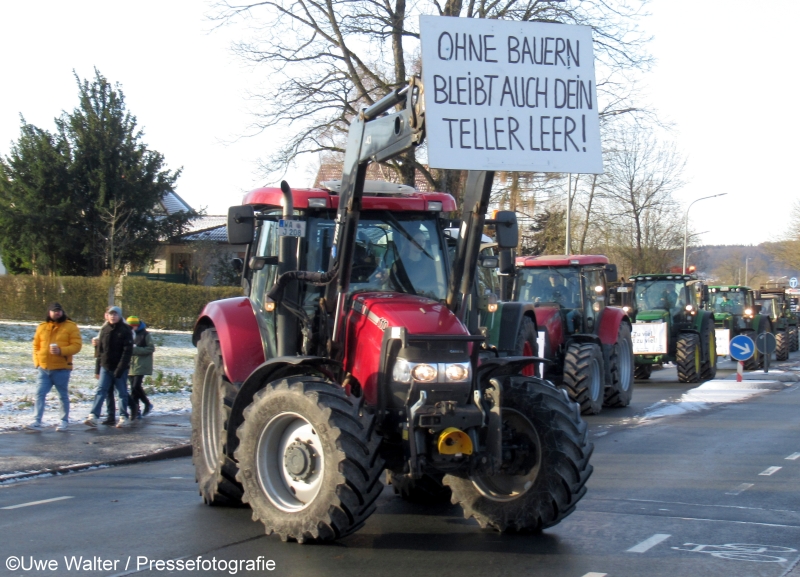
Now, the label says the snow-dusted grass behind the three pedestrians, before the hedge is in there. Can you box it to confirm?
[0,319,195,431]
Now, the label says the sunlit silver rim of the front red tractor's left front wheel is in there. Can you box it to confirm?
[256,413,325,512]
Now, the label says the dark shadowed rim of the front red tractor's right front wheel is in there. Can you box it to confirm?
[471,409,542,502]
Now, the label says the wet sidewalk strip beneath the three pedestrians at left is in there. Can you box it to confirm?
[0,412,192,484]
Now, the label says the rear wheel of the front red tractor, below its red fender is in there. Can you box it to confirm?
[191,329,242,506]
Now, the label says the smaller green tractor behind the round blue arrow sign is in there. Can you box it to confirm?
[708,285,773,371]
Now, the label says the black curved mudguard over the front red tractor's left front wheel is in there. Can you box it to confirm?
[227,357,337,455]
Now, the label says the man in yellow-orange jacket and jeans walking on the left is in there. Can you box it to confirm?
[27,303,83,431]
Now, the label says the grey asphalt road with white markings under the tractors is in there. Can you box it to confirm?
[0,362,800,577]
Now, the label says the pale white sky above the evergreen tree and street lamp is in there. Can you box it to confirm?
[0,0,800,244]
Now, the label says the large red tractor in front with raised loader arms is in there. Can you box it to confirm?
[186,81,592,542]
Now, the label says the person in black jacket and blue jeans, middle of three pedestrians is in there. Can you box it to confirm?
[84,306,133,428]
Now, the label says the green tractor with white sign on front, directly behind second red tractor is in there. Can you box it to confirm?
[628,274,717,383]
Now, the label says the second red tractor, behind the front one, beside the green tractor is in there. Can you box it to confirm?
[513,255,634,414]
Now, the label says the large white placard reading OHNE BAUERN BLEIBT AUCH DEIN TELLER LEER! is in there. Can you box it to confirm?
[420,16,603,174]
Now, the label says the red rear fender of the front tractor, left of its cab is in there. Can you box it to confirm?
[192,297,266,383]
